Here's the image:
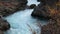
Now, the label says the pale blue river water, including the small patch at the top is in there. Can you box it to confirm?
[5,0,46,34]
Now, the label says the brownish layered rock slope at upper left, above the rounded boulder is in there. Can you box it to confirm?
[0,0,27,16]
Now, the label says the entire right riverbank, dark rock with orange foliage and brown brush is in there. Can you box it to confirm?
[31,0,60,34]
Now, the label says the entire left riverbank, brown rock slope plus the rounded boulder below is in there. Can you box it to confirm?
[0,0,27,34]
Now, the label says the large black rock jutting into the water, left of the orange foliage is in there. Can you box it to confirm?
[31,7,51,19]
